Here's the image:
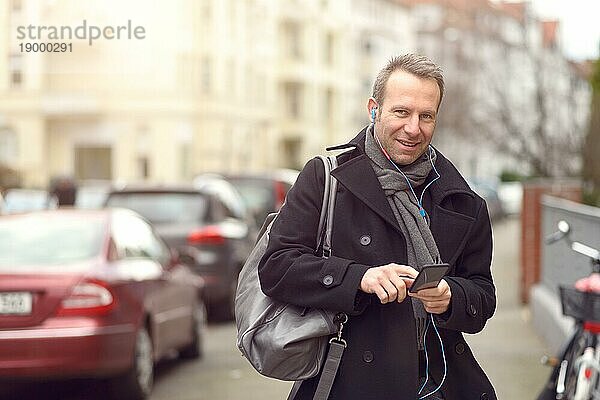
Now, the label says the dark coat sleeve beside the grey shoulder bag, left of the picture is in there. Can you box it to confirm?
[258,158,369,314]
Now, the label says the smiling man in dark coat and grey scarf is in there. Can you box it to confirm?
[259,54,496,400]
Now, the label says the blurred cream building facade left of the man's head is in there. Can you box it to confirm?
[0,0,413,187]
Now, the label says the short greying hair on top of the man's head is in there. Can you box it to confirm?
[372,53,444,107]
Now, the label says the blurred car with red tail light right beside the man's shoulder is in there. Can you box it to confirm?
[214,169,300,226]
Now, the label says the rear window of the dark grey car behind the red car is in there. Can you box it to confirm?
[107,192,207,224]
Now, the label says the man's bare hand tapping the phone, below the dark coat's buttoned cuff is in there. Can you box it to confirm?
[360,263,419,304]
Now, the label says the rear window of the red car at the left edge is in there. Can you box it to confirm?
[0,214,105,271]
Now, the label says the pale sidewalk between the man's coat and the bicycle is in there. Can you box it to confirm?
[465,218,550,400]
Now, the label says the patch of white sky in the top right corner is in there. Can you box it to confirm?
[532,0,600,61]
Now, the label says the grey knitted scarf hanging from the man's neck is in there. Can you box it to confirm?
[365,124,440,350]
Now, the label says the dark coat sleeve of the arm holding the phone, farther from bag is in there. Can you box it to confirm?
[437,200,496,333]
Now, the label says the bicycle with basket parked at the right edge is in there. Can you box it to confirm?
[538,221,600,400]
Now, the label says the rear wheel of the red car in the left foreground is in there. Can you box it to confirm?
[109,327,154,400]
